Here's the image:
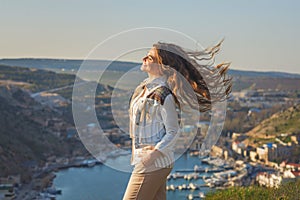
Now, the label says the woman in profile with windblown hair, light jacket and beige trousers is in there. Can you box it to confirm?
[123,42,231,200]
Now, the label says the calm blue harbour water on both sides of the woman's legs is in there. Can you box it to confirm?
[53,154,210,200]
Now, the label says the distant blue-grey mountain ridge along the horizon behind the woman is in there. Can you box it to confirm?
[0,58,300,78]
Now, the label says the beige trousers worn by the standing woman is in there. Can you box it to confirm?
[123,164,172,200]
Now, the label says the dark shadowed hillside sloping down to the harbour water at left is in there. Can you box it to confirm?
[0,84,84,178]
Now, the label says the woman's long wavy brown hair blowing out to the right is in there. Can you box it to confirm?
[153,40,232,112]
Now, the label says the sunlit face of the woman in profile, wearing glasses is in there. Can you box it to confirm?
[141,47,160,75]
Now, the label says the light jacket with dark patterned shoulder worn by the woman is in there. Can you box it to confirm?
[130,76,179,167]
